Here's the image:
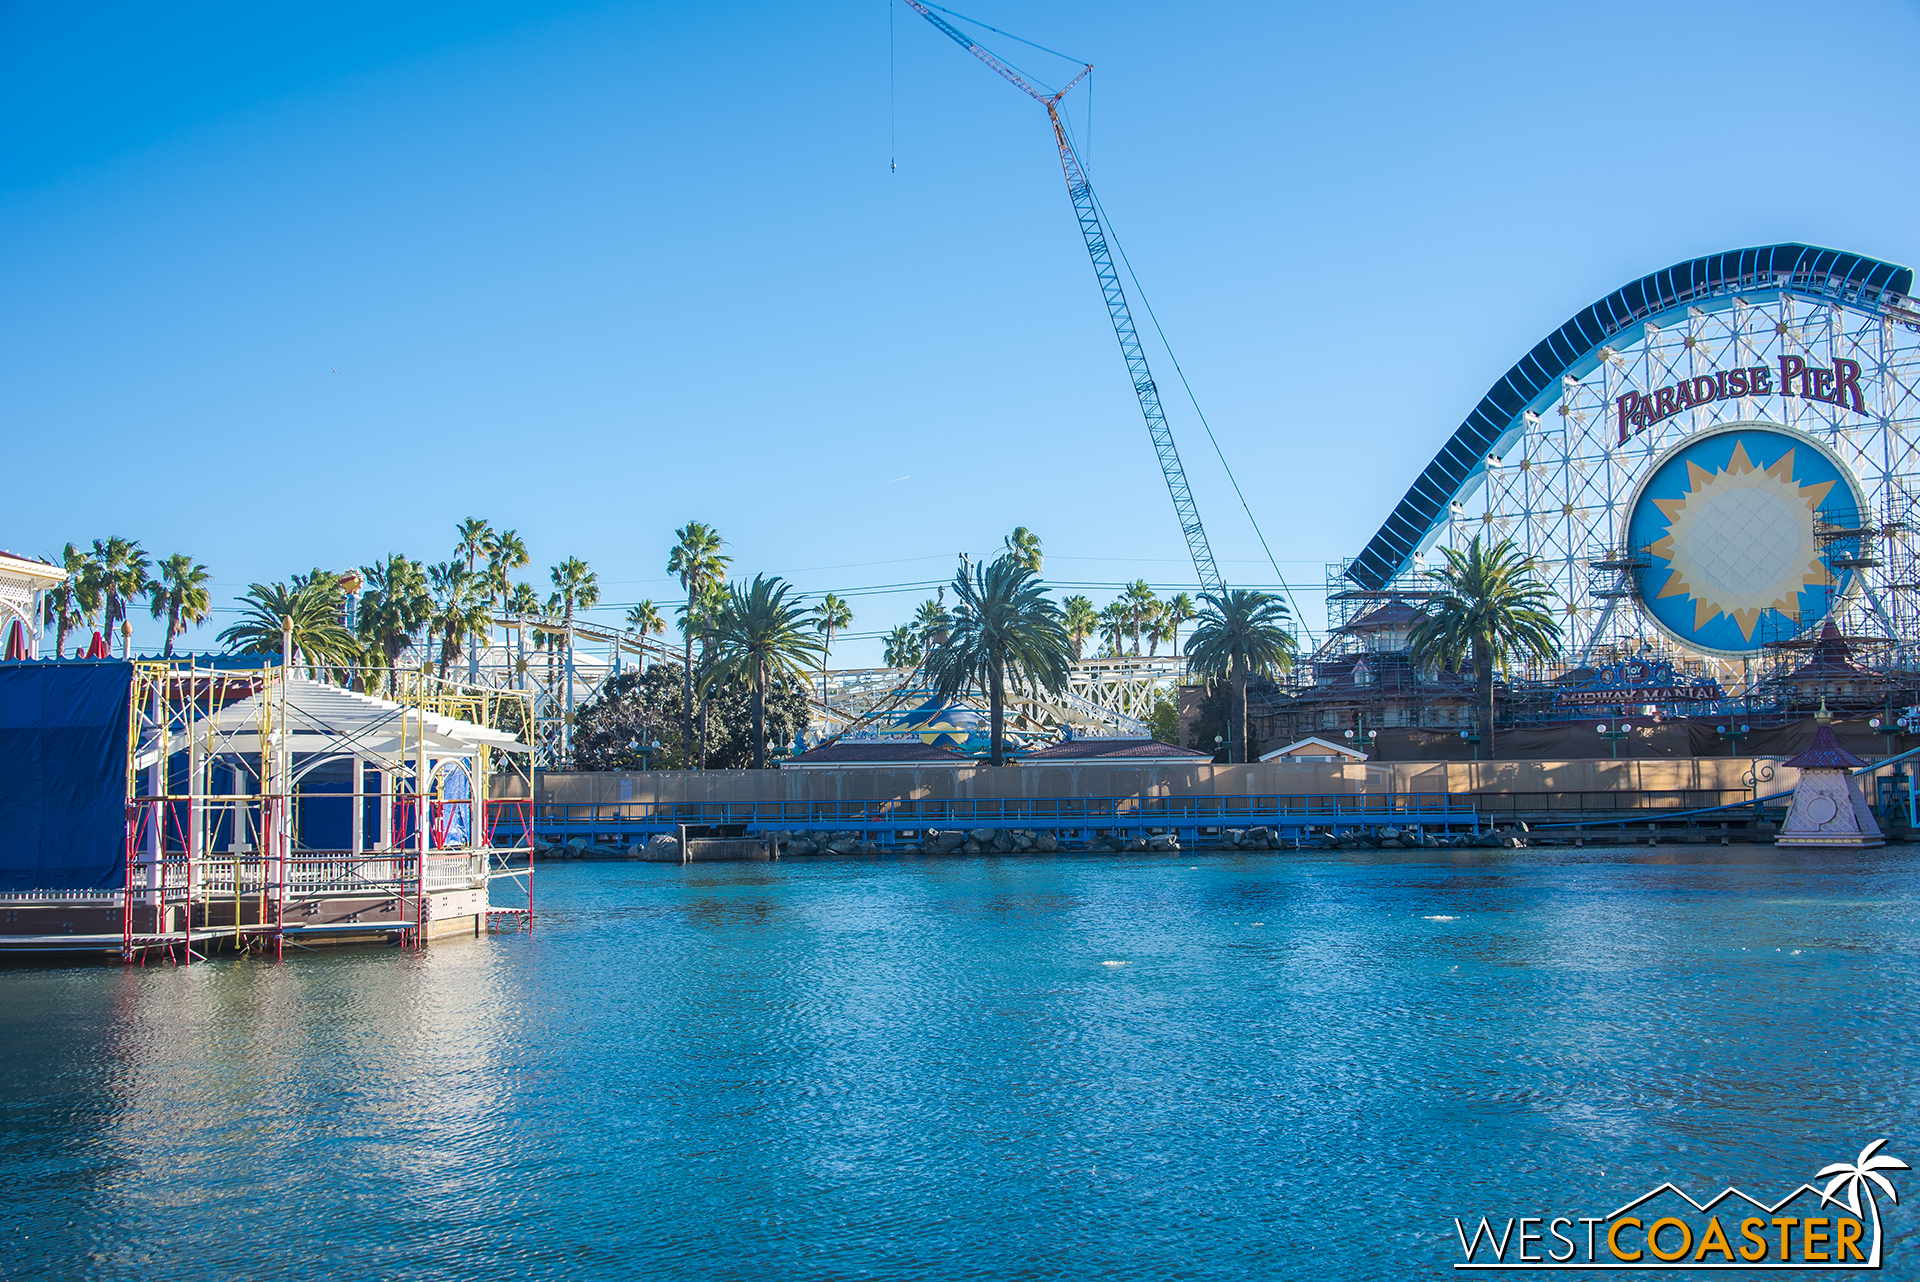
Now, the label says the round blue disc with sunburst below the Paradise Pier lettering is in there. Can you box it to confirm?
[1626,422,1866,658]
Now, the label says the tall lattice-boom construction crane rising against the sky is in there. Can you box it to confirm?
[902,0,1225,595]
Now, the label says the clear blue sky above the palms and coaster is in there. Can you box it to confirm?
[0,0,1920,666]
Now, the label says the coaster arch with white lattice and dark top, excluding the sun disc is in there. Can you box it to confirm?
[1346,244,1920,666]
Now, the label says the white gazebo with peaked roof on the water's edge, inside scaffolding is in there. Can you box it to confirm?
[134,668,532,938]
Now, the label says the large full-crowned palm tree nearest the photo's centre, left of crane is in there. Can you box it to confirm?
[927,557,1073,766]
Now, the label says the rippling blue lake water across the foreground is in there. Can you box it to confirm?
[0,846,1920,1278]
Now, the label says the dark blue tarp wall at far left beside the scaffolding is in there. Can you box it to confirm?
[0,658,132,894]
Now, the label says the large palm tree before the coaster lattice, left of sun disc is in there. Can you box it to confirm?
[1407,535,1561,758]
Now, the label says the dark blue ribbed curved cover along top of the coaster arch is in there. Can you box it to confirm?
[1346,244,1914,589]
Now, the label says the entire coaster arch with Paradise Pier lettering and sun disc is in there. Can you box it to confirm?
[1340,244,1920,675]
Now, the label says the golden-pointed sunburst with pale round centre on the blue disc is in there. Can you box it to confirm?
[1649,443,1834,641]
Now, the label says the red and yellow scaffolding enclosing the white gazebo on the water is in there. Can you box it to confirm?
[119,660,534,963]
